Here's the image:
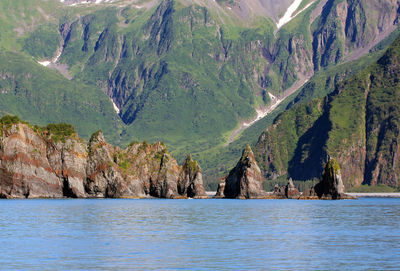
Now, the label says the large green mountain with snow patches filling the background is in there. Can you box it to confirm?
[0,0,399,188]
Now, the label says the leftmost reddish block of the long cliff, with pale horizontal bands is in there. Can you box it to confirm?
[0,124,63,198]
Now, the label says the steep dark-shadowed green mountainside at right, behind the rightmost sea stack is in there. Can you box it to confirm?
[255,35,400,188]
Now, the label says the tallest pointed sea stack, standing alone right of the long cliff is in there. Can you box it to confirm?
[224,145,266,199]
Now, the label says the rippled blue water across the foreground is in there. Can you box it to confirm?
[0,198,400,270]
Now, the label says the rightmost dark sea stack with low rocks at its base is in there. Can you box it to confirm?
[301,158,353,200]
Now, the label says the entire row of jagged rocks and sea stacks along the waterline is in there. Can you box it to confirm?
[0,116,362,200]
